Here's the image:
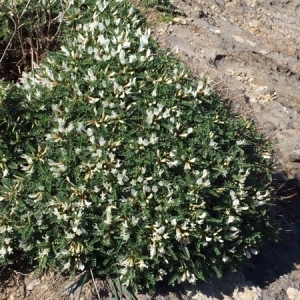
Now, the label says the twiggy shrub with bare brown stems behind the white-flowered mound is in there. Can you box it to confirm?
[0,0,69,80]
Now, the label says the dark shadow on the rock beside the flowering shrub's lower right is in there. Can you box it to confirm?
[243,179,300,288]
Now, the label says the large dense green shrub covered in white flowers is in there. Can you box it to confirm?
[0,0,274,289]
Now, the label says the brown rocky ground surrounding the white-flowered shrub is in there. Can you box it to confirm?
[0,0,300,300]
